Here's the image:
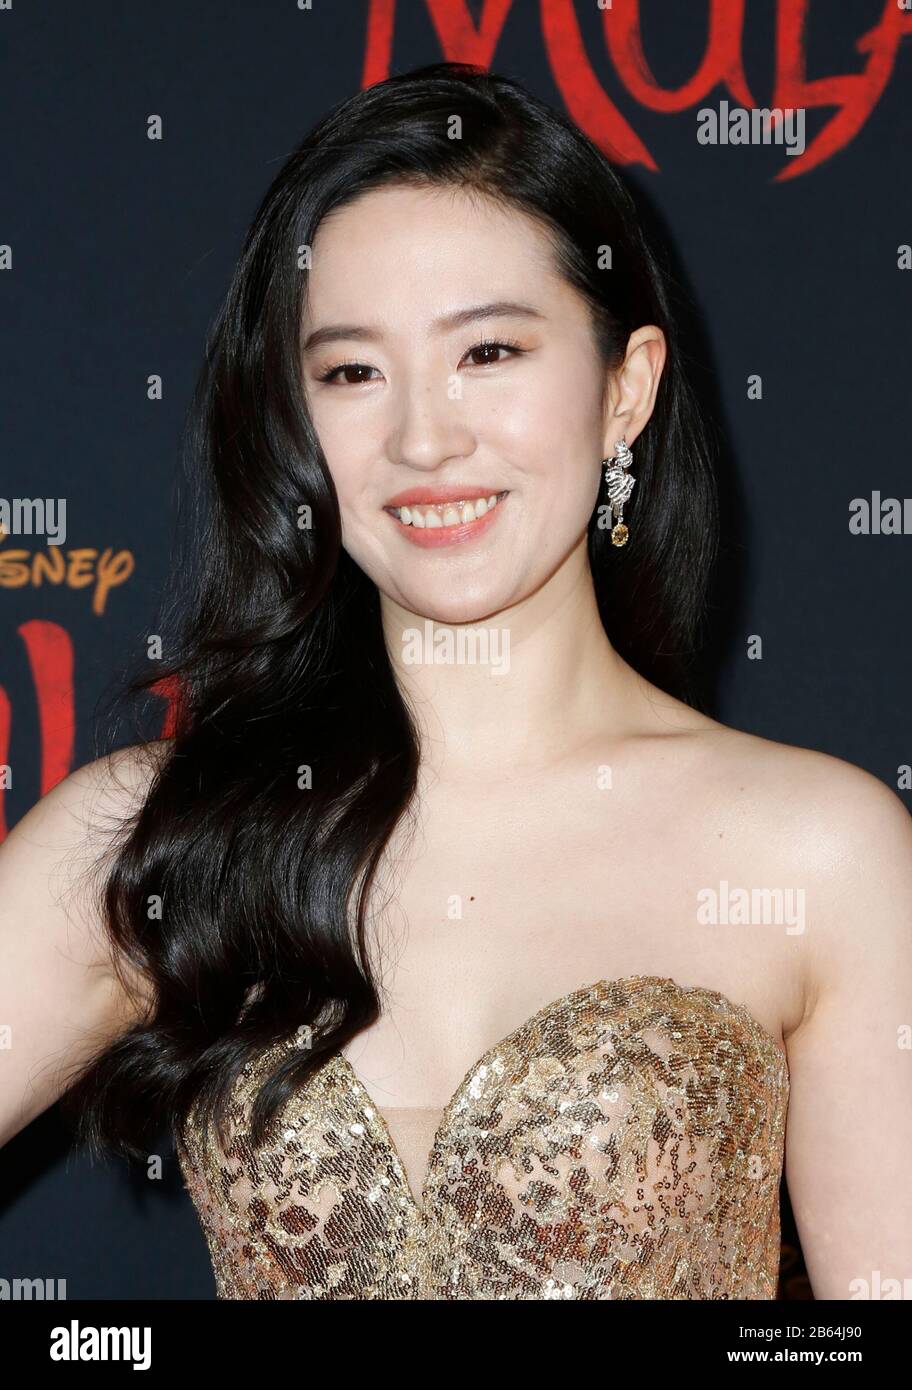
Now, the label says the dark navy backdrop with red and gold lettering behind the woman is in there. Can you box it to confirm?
[0,0,912,1298]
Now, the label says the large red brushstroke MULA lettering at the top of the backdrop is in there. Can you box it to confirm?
[361,0,912,182]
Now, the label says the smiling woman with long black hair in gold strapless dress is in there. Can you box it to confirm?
[0,64,912,1300]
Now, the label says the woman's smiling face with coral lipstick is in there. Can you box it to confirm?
[302,186,630,623]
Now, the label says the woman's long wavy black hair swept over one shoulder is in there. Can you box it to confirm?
[64,63,717,1158]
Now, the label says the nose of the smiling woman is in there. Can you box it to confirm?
[386,371,475,471]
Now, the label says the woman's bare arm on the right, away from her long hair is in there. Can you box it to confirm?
[785,760,912,1298]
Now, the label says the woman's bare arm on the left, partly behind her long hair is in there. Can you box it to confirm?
[0,741,167,1144]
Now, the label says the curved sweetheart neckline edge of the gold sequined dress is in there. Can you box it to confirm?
[329,974,788,1223]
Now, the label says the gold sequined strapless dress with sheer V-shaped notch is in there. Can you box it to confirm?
[177,976,790,1300]
